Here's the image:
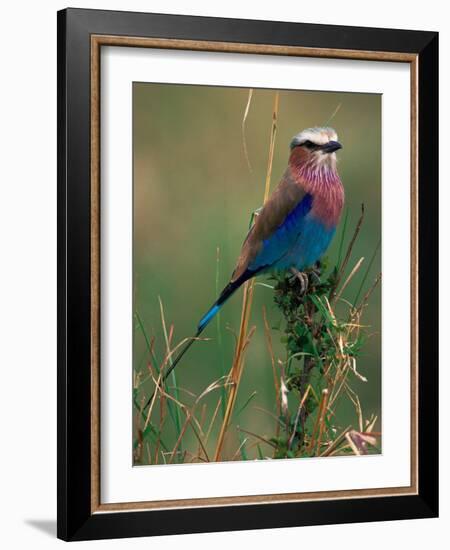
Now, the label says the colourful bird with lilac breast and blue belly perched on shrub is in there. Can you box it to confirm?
[144,127,345,410]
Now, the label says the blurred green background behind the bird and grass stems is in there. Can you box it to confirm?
[133,83,381,462]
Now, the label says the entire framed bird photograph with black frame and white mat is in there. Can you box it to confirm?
[58,9,438,540]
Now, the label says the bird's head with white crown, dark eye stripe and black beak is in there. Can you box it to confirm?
[290,128,342,172]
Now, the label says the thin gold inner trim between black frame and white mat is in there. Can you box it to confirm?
[91,35,419,514]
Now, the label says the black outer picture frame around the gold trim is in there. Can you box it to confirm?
[57,9,438,540]
